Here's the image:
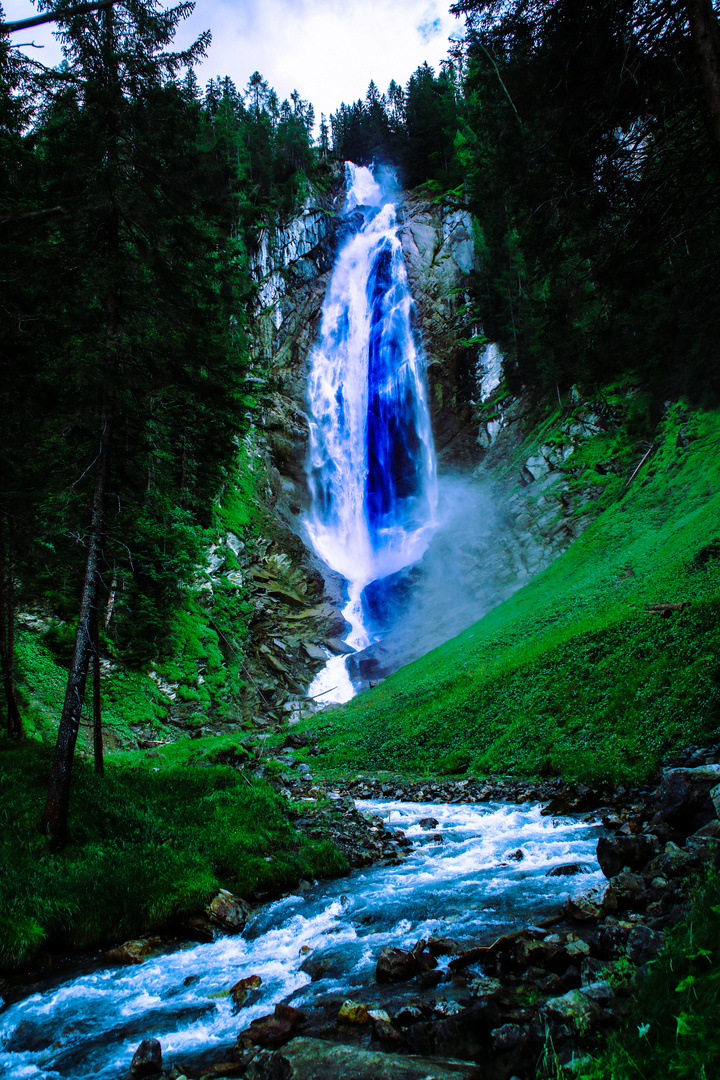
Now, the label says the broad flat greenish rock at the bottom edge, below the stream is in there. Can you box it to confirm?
[245,1038,480,1080]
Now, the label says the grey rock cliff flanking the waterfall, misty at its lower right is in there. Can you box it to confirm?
[239,177,598,679]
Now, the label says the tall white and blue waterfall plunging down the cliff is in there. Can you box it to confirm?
[305,163,437,702]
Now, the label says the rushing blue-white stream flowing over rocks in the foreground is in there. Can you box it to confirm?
[0,801,602,1080]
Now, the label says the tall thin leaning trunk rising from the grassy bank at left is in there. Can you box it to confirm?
[43,8,120,849]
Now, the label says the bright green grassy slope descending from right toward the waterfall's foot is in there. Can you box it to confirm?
[308,406,720,781]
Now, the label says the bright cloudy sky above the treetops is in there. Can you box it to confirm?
[0,0,462,120]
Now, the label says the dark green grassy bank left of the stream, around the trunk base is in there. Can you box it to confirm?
[0,740,347,970]
